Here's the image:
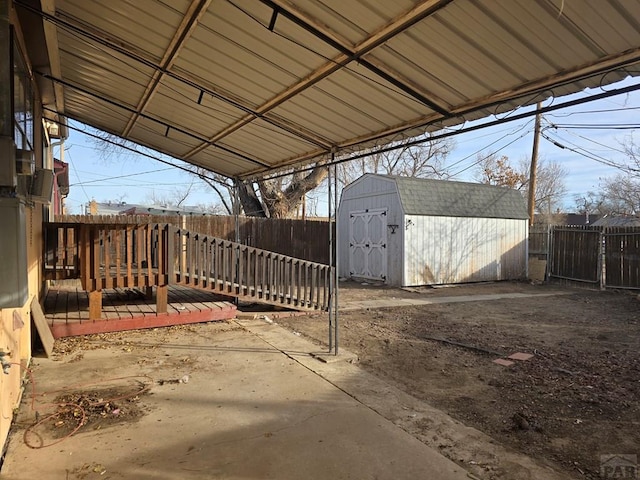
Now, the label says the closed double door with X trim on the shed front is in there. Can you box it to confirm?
[349,209,387,281]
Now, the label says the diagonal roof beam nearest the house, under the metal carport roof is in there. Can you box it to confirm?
[122,0,211,137]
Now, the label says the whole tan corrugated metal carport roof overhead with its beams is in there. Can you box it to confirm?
[15,0,640,178]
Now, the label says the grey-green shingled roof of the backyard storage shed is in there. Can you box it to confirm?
[358,174,529,219]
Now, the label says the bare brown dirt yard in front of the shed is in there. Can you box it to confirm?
[277,282,640,479]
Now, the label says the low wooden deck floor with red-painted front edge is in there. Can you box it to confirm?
[44,282,236,338]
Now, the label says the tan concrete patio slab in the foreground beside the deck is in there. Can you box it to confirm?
[1,320,469,480]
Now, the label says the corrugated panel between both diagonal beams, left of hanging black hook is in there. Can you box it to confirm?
[175,2,336,108]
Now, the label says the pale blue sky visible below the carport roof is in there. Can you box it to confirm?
[61,81,640,213]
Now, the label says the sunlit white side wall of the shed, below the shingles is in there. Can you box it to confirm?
[402,215,527,286]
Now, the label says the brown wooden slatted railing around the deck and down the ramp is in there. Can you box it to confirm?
[44,223,331,318]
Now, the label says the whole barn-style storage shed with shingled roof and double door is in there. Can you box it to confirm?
[337,173,528,286]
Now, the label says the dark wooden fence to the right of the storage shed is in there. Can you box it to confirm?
[548,226,640,289]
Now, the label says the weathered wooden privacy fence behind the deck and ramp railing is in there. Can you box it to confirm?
[55,215,335,264]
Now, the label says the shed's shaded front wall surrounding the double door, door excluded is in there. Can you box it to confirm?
[336,175,404,284]
